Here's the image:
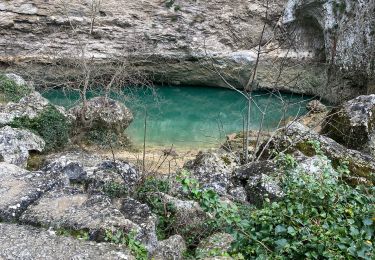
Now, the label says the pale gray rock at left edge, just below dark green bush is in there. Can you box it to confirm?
[0,126,45,167]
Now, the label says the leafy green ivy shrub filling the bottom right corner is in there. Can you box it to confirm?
[181,150,375,259]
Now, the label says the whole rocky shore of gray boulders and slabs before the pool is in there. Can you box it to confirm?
[0,75,375,259]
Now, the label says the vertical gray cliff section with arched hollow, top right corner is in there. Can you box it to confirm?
[282,0,375,101]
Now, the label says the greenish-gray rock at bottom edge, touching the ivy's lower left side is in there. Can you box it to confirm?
[196,233,234,259]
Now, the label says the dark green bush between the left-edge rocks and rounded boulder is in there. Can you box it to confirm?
[10,105,71,152]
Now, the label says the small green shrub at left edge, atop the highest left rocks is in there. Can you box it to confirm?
[0,75,31,103]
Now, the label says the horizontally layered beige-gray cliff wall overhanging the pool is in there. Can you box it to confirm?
[0,0,364,99]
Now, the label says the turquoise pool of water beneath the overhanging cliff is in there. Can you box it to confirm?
[44,87,309,147]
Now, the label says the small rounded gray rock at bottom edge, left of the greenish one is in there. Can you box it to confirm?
[152,235,186,260]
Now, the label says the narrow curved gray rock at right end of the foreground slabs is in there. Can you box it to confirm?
[120,198,158,253]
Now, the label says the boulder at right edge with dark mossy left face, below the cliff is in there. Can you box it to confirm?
[322,95,375,156]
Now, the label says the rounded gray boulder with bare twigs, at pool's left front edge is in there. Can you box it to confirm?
[70,97,133,134]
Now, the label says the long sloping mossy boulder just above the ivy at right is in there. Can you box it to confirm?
[258,122,375,184]
